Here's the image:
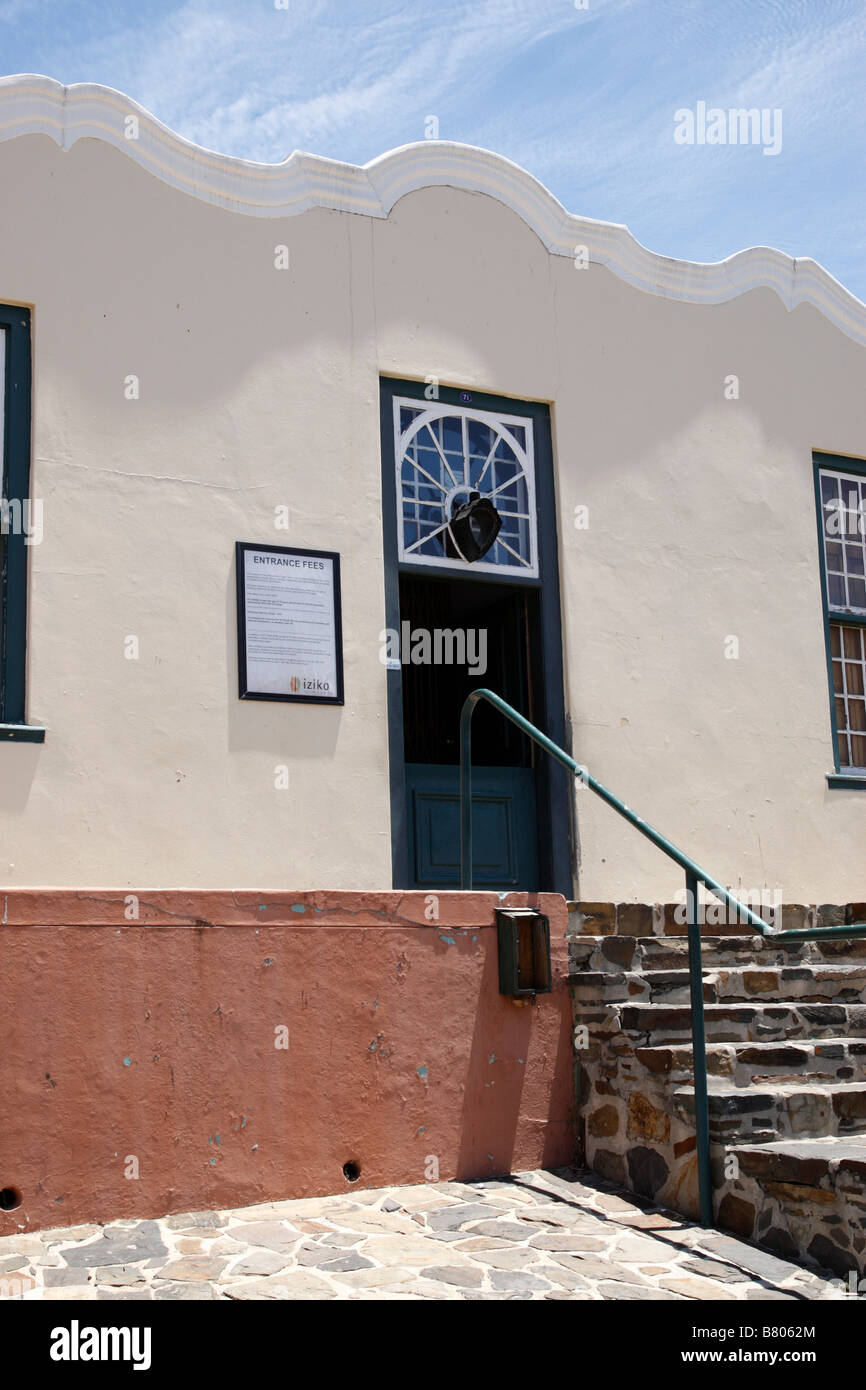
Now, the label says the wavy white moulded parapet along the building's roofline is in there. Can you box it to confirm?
[0,75,866,345]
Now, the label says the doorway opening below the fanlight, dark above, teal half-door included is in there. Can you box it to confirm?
[400,574,539,890]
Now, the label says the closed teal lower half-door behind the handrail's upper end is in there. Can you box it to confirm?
[406,763,538,891]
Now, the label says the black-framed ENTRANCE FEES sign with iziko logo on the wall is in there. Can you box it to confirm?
[235,541,343,705]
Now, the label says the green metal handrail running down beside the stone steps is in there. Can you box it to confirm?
[460,689,866,1226]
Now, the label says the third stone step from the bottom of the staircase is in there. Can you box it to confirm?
[635,1037,866,1087]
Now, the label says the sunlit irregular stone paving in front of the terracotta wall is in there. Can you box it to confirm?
[0,1172,844,1301]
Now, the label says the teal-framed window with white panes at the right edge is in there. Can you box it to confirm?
[815,455,866,787]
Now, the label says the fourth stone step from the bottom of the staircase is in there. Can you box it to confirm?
[617,1002,866,1047]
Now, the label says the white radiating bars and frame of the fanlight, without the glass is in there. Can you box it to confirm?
[393,396,538,578]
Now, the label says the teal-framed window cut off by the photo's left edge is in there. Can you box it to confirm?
[0,304,44,742]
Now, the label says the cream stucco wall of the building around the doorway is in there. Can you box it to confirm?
[0,111,866,902]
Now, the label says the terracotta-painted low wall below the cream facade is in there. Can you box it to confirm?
[0,890,574,1234]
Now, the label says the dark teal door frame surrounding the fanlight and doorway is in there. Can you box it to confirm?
[379,375,573,898]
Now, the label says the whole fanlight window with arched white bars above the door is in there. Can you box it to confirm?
[393,398,538,578]
